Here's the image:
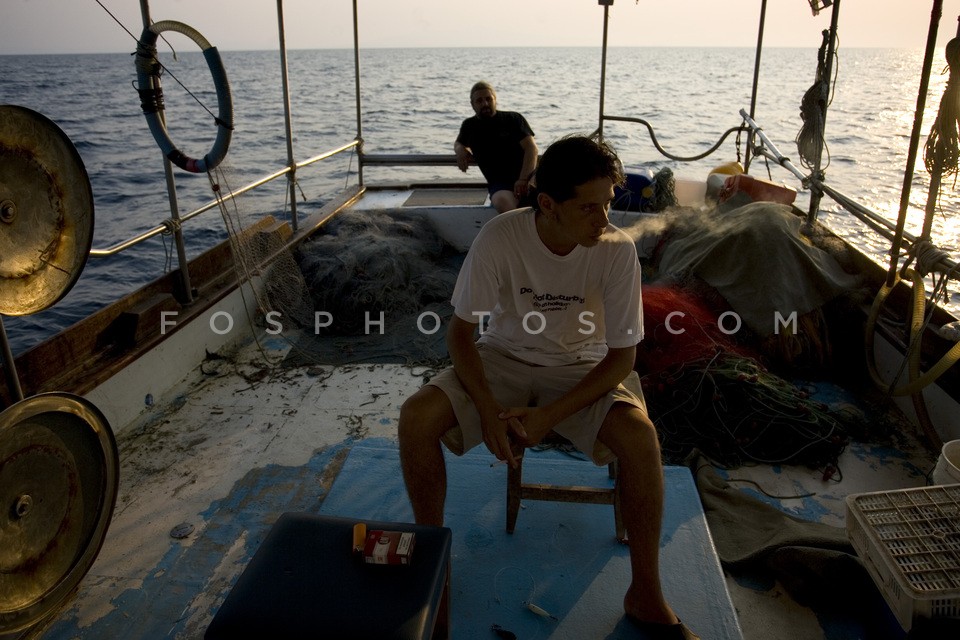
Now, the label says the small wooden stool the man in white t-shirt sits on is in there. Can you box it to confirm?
[507,440,627,542]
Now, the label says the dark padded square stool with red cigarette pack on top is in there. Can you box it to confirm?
[204,513,452,640]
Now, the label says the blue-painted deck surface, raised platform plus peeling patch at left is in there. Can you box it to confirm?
[37,438,741,640]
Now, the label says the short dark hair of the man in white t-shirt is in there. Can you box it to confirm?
[535,135,625,206]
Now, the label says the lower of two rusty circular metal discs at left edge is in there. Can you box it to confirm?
[0,393,119,636]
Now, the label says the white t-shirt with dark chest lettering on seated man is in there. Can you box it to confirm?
[451,208,643,366]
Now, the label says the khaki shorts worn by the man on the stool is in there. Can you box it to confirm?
[427,345,647,465]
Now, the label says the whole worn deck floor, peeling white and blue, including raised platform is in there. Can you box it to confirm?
[31,356,935,640]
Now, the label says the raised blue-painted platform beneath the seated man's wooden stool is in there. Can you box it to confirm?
[320,442,741,640]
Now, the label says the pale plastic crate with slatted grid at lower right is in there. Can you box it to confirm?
[846,484,960,631]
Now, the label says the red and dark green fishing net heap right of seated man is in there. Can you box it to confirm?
[637,285,864,467]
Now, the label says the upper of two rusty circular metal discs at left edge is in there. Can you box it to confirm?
[0,105,93,316]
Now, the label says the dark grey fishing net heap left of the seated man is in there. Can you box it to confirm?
[286,211,463,364]
